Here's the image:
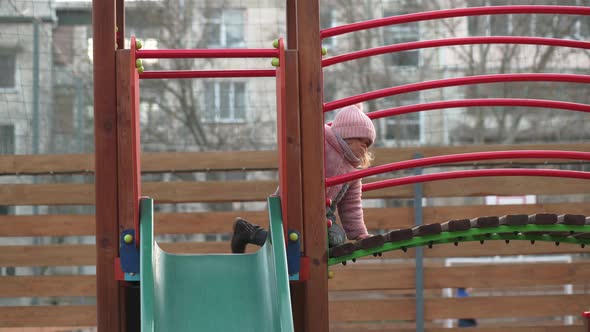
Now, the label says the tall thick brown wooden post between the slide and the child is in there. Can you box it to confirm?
[287,0,329,332]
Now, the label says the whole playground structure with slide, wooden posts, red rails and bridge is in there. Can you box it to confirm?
[93,1,590,331]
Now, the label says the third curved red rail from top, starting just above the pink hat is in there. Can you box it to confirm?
[324,73,590,112]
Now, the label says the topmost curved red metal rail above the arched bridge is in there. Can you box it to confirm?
[320,5,590,39]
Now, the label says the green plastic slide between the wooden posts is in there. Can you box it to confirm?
[140,197,293,332]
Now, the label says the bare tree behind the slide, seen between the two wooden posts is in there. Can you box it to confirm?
[130,0,274,151]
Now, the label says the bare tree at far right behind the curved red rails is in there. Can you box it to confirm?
[426,0,588,144]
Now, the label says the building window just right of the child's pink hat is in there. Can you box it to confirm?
[384,92,420,144]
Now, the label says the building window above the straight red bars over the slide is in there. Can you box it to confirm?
[206,8,246,47]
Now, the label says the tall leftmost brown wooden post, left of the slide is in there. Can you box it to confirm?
[92,0,122,332]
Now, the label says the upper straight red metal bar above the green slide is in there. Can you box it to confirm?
[135,48,279,59]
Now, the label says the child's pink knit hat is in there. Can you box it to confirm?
[332,104,375,146]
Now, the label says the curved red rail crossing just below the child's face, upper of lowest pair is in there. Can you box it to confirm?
[326,150,590,187]
